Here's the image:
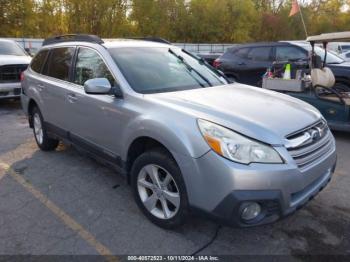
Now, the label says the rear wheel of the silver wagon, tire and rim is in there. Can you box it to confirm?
[32,107,59,151]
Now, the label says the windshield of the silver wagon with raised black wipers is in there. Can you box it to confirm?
[108,47,227,94]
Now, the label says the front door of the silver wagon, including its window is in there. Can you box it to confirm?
[69,47,124,161]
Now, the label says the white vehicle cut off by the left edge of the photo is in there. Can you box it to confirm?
[0,39,31,99]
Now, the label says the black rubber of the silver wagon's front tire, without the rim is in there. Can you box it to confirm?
[130,149,188,229]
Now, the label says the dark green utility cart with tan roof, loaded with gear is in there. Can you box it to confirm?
[262,32,350,132]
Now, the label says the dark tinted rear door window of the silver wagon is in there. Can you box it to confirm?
[45,47,75,81]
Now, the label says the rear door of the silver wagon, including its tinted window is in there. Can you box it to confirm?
[40,47,76,136]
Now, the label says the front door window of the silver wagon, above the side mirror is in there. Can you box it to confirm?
[74,47,115,86]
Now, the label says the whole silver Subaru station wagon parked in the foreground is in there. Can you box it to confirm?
[21,35,336,228]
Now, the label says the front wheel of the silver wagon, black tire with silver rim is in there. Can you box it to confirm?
[131,149,188,229]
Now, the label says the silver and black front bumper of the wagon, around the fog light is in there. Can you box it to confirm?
[180,139,336,227]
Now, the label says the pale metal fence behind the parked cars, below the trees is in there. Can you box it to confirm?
[9,38,235,54]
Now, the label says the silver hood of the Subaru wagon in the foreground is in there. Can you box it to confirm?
[147,83,321,145]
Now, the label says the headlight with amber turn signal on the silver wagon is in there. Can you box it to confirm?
[198,119,283,164]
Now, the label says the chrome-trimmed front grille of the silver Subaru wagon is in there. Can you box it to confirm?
[286,121,334,169]
